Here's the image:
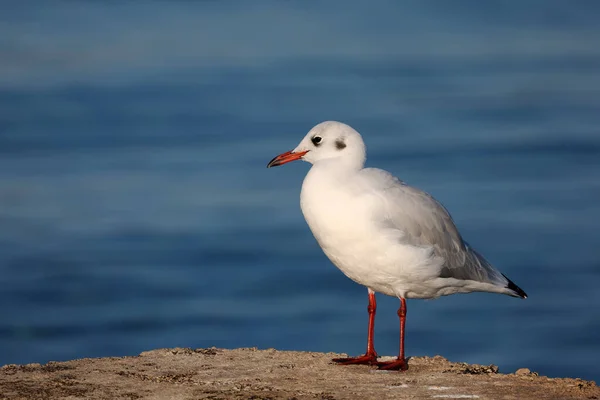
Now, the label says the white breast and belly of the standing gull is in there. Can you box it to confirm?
[300,167,431,296]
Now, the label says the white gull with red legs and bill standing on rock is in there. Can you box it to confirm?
[267,121,527,371]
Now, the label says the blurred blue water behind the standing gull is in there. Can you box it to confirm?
[0,0,600,379]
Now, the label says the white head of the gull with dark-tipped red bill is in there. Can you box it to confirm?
[267,121,366,169]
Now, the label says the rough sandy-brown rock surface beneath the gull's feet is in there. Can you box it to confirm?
[0,348,600,399]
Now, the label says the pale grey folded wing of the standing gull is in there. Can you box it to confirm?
[368,170,509,286]
